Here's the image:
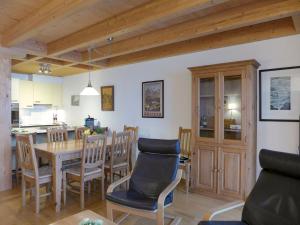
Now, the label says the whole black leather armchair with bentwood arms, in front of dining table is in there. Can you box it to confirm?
[106,138,182,225]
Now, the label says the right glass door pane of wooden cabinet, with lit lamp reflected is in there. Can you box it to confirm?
[223,75,242,140]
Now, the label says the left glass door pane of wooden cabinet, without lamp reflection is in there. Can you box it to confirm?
[199,77,215,138]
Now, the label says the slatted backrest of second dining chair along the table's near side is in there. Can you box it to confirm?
[110,131,131,166]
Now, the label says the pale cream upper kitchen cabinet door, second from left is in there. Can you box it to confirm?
[19,80,33,108]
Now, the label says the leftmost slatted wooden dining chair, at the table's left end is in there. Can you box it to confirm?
[16,135,52,213]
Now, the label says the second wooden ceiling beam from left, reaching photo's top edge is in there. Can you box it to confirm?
[48,0,228,55]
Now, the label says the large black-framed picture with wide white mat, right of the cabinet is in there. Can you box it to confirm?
[259,66,300,122]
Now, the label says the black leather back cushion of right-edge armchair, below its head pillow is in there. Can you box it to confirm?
[242,170,300,225]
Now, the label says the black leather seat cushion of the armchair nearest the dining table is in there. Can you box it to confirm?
[106,191,173,211]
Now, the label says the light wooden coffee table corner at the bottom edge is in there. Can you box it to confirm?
[49,210,116,225]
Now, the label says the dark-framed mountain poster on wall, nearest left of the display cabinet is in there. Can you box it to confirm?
[142,80,164,118]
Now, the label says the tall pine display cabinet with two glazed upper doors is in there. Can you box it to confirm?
[189,60,259,199]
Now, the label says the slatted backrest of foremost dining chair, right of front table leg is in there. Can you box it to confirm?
[81,135,107,174]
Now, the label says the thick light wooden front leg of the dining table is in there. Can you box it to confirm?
[52,155,62,212]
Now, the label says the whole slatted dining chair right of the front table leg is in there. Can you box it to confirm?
[63,135,107,209]
